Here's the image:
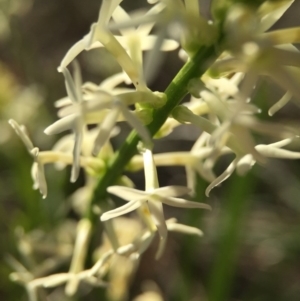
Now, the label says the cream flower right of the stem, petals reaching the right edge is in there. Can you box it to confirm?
[173,104,298,196]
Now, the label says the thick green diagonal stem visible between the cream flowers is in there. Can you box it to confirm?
[86,45,218,223]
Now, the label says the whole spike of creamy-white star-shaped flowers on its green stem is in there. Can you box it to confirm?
[9,0,300,301]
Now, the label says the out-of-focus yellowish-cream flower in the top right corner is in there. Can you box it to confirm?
[211,1,300,110]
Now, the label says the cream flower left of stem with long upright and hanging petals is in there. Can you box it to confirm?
[45,64,155,173]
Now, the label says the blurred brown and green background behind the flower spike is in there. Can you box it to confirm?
[0,0,300,301]
